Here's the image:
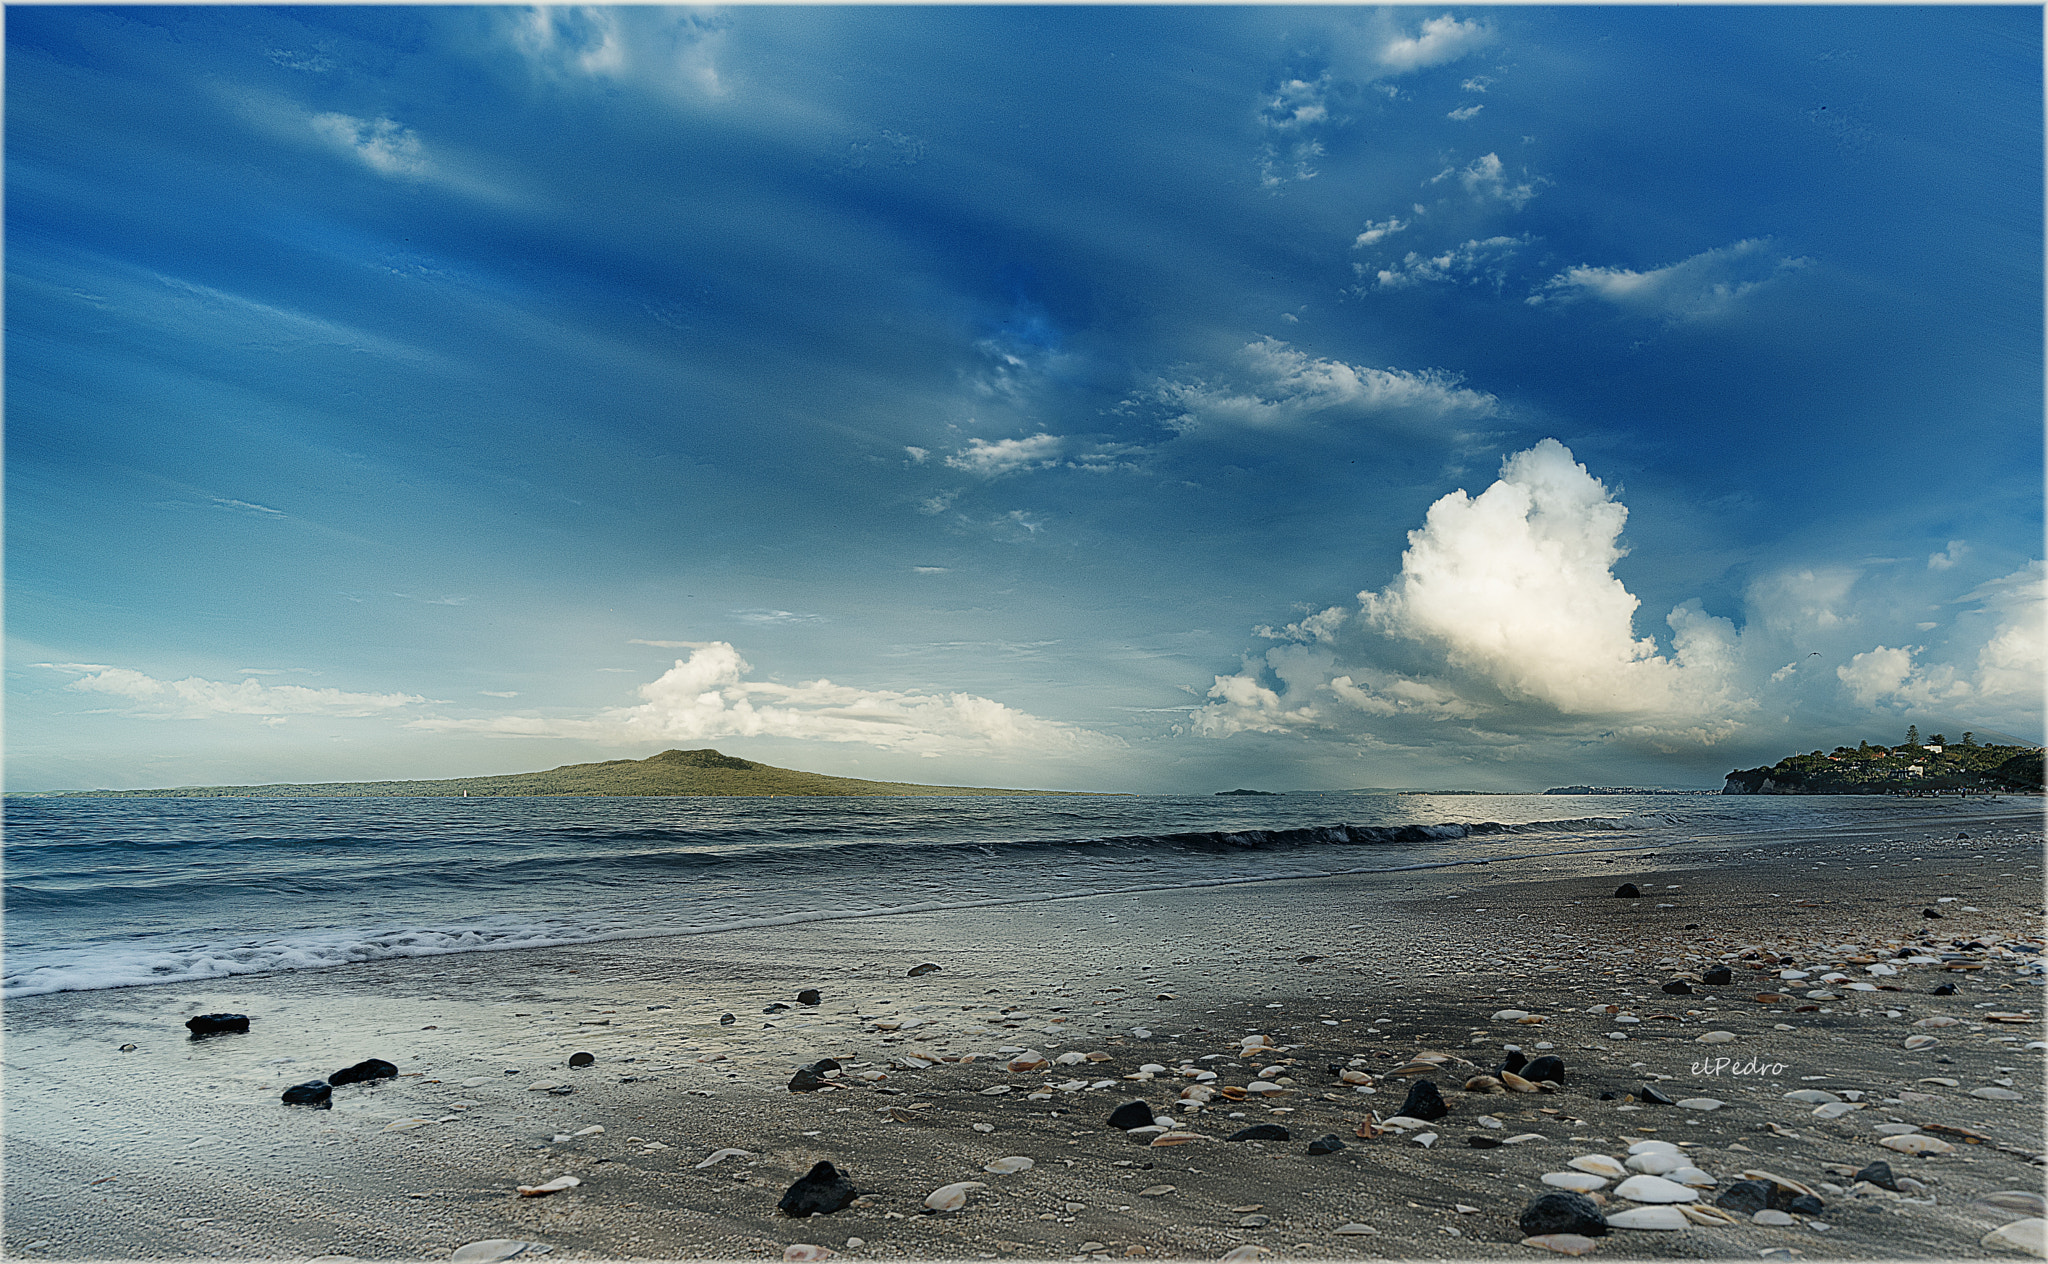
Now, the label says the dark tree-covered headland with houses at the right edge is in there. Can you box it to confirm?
[1720,727,2042,795]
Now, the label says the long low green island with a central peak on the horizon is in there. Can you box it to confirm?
[32,750,1105,799]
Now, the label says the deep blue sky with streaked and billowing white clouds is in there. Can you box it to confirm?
[6,6,2044,793]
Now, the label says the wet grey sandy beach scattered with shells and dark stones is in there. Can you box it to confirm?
[4,799,2048,1260]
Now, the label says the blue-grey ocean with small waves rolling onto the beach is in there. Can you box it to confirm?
[0,793,1964,998]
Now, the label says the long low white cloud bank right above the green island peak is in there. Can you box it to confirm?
[408,641,1114,756]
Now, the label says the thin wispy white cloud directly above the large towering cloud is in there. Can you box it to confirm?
[1151,338,1499,432]
